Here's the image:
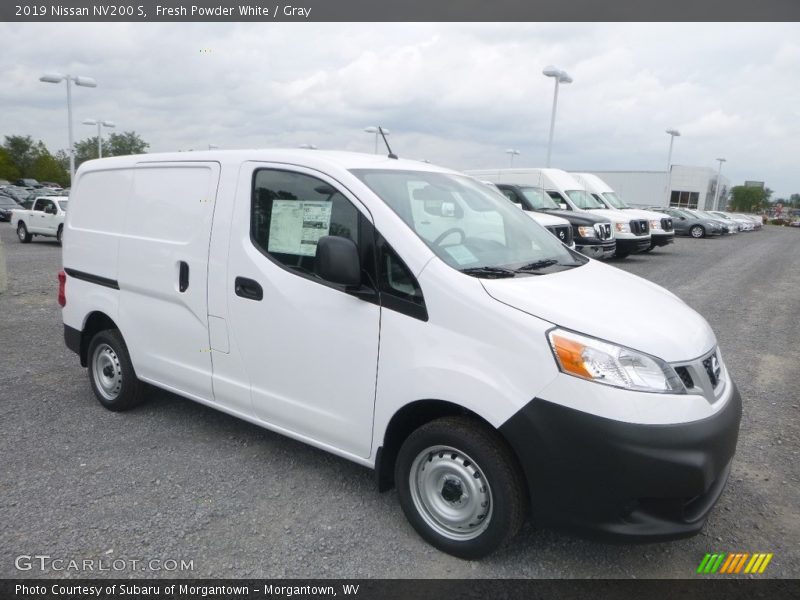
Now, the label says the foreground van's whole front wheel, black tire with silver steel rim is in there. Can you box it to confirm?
[395,416,528,560]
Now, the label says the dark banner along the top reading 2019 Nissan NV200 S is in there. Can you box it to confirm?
[0,0,800,22]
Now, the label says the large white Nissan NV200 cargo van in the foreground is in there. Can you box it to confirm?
[59,150,741,558]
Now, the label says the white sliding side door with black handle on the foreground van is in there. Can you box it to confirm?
[118,162,219,400]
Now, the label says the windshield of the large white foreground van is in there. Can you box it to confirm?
[352,169,588,278]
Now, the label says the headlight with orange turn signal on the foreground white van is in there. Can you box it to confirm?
[547,329,686,394]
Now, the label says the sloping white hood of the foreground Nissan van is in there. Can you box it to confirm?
[481,260,716,362]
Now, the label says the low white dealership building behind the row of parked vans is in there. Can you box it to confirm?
[584,165,730,210]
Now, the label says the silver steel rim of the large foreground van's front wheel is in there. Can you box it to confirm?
[408,446,493,541]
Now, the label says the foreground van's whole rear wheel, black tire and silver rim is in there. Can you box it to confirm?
[87,329,145,411]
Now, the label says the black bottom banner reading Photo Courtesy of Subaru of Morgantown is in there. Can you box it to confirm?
[0,578,800,600]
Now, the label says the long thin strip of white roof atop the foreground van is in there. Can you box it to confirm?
[79,148,454,173]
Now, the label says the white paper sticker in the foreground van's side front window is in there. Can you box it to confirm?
[267,200,333,256]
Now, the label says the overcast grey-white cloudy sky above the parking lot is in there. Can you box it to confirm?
[0,23,800,197]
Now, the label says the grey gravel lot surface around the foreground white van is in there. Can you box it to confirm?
[0,223,800,578]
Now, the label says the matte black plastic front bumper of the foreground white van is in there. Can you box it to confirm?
[500,386,742,541]
